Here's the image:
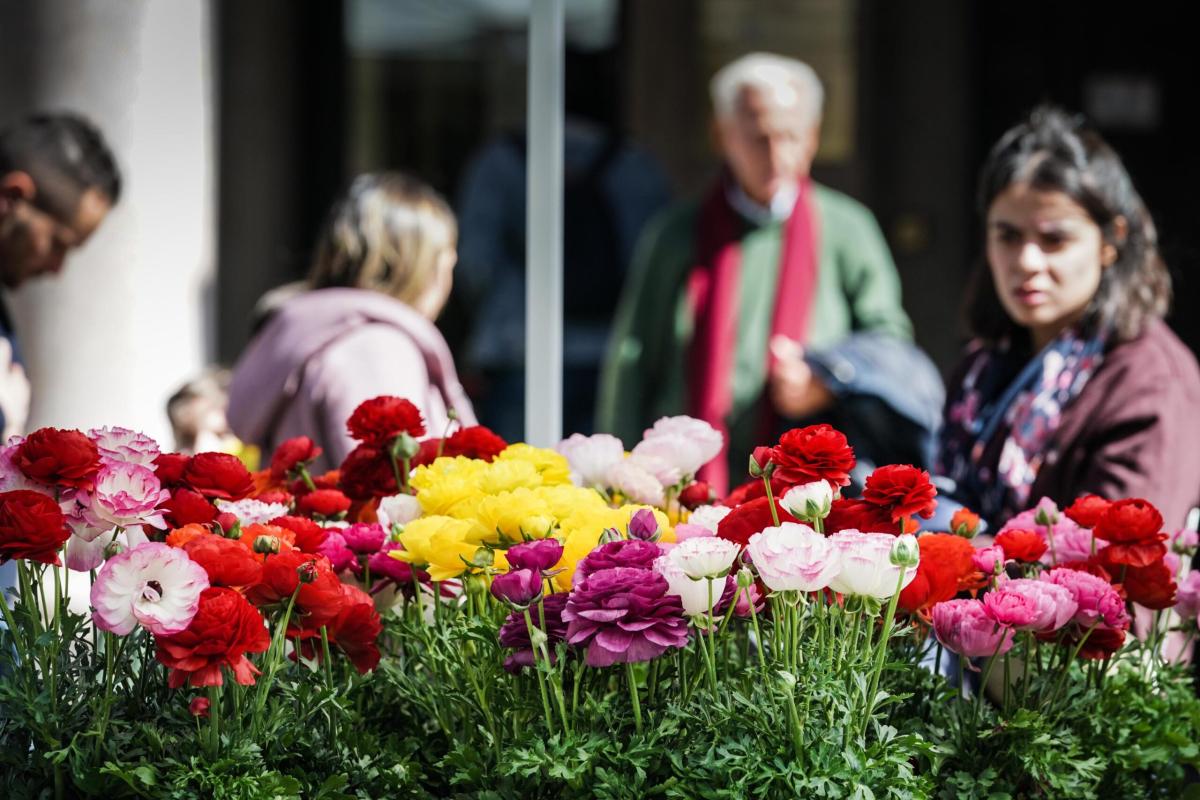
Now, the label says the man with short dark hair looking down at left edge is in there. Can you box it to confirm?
[0,114,121,439]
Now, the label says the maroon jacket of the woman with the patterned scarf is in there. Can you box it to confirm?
[1030,320,1200,530]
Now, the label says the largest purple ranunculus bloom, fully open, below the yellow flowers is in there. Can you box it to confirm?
[563,566,688,667]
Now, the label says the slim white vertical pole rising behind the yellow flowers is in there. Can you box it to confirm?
[526,0,563,447]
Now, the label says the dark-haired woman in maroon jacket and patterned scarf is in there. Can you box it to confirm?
[938,108,1200,527]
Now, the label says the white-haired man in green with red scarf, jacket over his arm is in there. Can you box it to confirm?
[598,53,941,492]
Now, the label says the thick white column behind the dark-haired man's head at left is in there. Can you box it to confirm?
[0,0,215,447]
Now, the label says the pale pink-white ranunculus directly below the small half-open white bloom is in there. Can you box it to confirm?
[746,522,840,591]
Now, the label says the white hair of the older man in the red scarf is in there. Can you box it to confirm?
[708,53,824,125]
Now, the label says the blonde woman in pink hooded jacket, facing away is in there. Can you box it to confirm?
[229,173,475,469]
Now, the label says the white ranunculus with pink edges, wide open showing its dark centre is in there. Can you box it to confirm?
[91,542,209,636]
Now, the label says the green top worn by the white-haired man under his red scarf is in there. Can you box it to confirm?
[596,184,912,476]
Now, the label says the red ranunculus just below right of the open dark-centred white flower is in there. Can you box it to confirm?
[155,587,271,688]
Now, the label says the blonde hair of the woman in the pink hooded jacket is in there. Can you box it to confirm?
[308,173,458,303]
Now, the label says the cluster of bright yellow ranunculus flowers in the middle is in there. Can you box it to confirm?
[391,444,674,591]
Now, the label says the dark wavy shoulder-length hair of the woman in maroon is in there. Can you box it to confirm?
[965,106,1171,342]
